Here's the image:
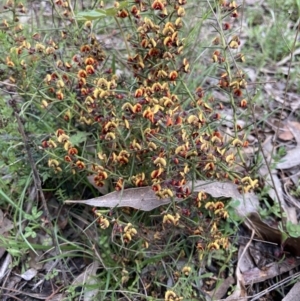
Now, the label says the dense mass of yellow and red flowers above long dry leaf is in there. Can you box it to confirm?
[35,1,253,202]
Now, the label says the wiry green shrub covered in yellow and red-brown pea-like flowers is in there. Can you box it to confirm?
[2,0,257,298]
